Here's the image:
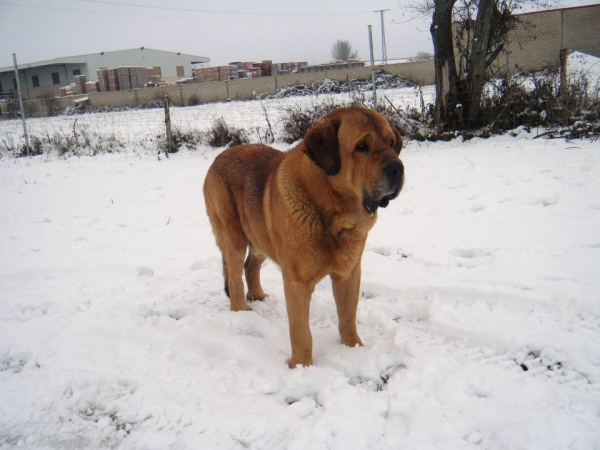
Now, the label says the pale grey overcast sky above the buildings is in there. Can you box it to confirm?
[0,0,598,67]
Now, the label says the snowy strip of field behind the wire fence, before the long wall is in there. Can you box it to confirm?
[0,87,434,153]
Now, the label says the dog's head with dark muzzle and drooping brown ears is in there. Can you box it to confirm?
[303,107,404,214]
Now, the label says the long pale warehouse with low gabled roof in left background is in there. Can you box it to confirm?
[0,47,210,100]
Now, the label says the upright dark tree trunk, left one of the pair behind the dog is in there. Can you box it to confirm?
[430,0,461,127]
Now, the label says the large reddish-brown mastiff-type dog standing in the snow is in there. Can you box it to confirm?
[204,107,404,367]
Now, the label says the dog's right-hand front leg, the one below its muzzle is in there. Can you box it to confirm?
[331,260,363,347]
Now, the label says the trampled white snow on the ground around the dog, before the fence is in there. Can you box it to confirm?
[0,93,600,450]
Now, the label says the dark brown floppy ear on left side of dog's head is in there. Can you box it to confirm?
[304,119,341,175]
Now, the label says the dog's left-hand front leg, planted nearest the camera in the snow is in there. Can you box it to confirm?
[283,273,315,368]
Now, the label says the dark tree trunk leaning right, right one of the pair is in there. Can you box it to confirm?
[463,0,496,127]
